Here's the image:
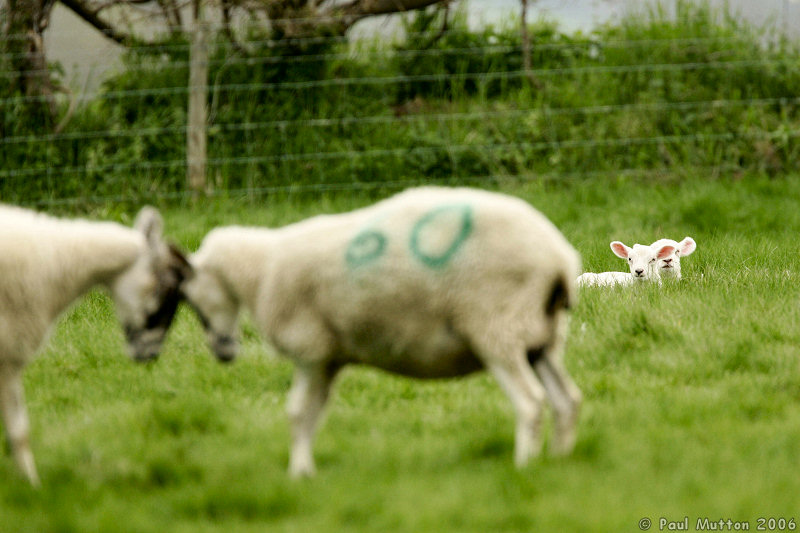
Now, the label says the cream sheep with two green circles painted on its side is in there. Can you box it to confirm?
[182,187,581,477]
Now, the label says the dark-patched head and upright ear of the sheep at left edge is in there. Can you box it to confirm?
[110,207,189,361]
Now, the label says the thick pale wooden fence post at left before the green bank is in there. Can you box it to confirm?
[186,0,208,194]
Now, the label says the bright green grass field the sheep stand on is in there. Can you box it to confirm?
[0,177,800,533]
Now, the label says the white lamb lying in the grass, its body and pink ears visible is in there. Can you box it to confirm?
[577,241,676,287]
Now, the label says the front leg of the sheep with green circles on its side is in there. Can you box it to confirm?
[287,364,336,478]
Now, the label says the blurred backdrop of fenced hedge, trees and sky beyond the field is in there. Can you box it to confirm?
[0,0,800,206]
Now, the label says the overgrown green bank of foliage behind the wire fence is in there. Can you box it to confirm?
[0,9,800,206]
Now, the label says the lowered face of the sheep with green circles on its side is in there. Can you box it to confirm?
[181,267,239,362]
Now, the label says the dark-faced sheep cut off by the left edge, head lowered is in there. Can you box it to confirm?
[0,205,189,486]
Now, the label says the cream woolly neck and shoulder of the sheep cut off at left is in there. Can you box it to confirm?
[0,206,144,364]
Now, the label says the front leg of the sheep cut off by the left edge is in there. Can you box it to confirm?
[0,364,39,487]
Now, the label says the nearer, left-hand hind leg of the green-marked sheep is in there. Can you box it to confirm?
[487,355,545,467]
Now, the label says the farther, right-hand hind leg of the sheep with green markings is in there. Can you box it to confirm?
[534,356,581,455]
